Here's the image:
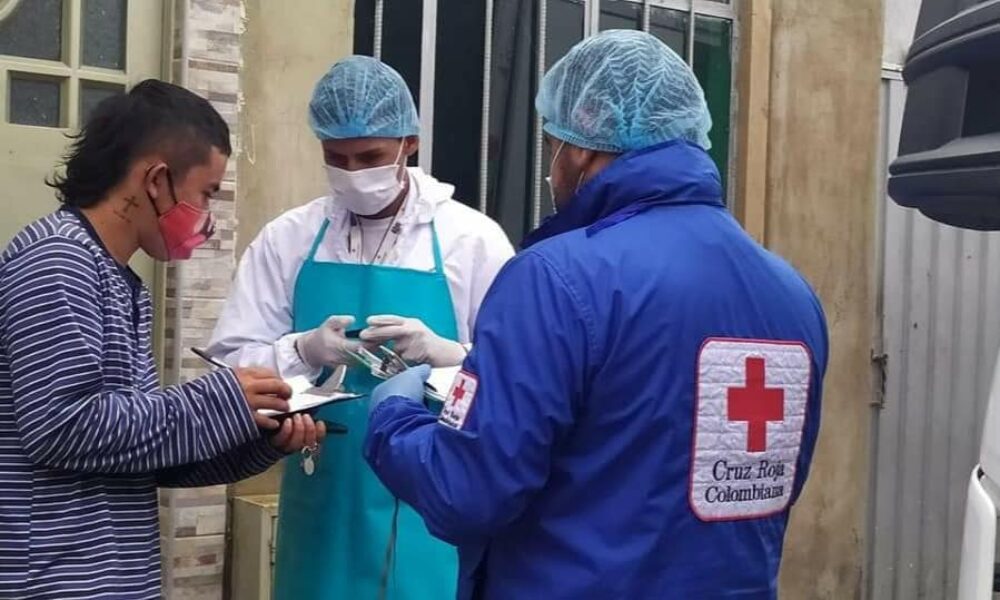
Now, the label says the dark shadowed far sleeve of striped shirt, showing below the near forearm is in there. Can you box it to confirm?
[156,437,286,487]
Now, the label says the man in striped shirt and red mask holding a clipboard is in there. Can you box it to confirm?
[0,80,325,600]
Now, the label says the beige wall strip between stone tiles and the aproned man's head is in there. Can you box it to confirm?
[236,0,354,256]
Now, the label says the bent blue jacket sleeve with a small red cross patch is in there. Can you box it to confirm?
[364,253,591,544]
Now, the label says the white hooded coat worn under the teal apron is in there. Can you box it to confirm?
[208,168,514,377]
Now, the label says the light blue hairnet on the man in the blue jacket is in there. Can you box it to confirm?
[535,31,712,153]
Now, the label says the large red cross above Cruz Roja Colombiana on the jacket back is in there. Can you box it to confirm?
[728,357,785,452]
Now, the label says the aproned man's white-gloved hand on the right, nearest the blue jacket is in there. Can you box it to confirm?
[361,315,466,367]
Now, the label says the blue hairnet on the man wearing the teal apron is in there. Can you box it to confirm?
[309,56,420,140]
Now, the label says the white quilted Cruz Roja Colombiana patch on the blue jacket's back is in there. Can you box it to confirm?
[690,339,812,521]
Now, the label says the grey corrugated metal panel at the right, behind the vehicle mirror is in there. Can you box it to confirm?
[867,76,1000,600]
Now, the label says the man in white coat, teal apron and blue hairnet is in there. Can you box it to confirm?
[209,56,514,600]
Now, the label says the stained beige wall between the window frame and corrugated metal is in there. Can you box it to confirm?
[752,0,882,600]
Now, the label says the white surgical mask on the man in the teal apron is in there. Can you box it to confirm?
[326,140,405,217]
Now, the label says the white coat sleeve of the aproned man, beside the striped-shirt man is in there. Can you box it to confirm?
[201,228,320,378]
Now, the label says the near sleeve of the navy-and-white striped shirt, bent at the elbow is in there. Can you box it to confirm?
[0,238,260,473]
